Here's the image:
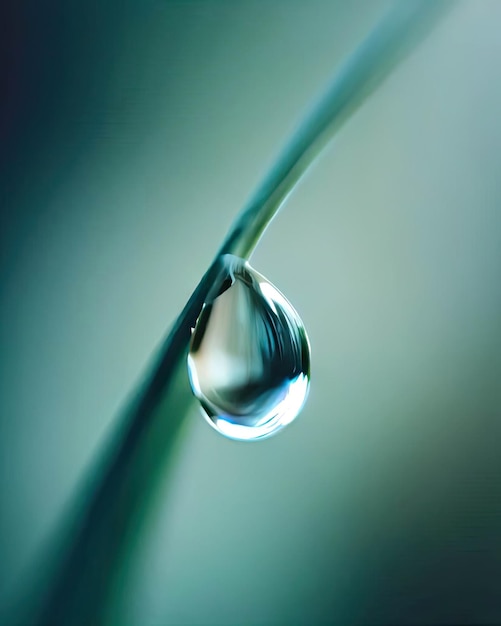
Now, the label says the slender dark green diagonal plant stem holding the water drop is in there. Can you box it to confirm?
[36,0,449,626]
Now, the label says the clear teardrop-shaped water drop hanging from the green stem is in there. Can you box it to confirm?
[188,255,310,441]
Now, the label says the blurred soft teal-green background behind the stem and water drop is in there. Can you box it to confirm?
[0,0,501,624]
